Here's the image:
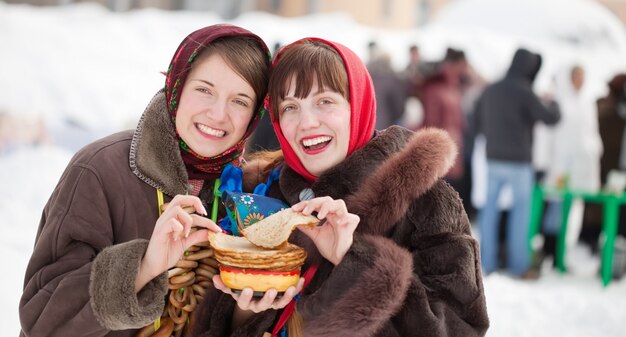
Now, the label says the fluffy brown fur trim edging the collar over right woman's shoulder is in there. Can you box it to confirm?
[346,128,457,234]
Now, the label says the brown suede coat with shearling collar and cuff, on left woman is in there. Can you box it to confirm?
[19,92,217,337]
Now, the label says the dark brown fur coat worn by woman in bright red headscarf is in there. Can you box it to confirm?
[191,127,489,337]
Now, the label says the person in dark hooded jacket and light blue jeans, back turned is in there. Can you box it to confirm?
[475,49,560,277]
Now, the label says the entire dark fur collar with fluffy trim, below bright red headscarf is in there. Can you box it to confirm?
[280,126,457,234]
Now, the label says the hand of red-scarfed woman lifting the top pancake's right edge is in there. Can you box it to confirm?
[291,197,361,265]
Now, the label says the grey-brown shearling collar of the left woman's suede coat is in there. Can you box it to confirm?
[129,90,189,196]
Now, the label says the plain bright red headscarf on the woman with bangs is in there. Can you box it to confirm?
[266,38,376,182]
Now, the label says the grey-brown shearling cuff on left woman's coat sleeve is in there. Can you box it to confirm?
[89,239,167,330]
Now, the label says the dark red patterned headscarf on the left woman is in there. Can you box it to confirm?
[165,24,270,179]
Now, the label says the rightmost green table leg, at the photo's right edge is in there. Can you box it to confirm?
[600,197,619,287]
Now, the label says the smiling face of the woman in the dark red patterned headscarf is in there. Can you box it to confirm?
[176,53,256,157]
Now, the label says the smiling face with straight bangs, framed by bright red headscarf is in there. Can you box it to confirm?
[278,78,350,177]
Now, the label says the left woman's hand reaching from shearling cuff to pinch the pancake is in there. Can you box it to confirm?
[135,195,222,291]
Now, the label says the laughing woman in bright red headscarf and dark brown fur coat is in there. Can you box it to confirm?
[191,38,489,337]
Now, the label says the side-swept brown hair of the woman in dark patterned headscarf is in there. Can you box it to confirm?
[191,36,270,111]
